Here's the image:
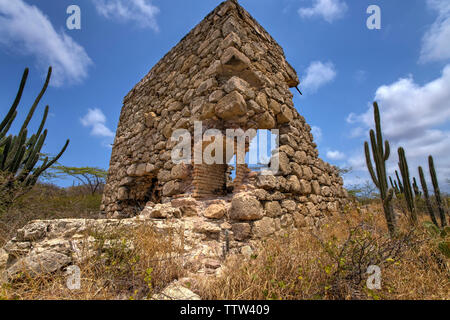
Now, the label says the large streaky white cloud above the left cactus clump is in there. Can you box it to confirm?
[0,0,92,86]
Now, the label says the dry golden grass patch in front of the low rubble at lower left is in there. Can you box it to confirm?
[0,225,184,300]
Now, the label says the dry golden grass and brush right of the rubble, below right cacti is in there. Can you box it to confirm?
[196,207,450,300]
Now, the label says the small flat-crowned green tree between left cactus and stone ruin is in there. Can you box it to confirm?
[51,165,108,195]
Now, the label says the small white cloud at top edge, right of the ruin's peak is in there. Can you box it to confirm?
[298,0,348,23]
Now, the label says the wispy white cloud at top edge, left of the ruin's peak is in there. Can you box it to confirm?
[93,0,159,32]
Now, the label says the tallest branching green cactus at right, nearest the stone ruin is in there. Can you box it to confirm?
[364,102,396,236]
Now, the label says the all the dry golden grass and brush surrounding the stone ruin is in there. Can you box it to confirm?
[0,185,450,300]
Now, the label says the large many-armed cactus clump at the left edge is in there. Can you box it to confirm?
[0,67,69,202]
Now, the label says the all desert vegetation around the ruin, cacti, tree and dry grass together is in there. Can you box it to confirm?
[0,69,450,300]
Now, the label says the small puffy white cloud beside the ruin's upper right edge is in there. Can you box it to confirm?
[302,61,337,93]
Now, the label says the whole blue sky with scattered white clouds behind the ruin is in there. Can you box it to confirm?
[0,0,450,190]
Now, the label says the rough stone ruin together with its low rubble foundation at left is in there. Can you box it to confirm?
[0,0,347,284]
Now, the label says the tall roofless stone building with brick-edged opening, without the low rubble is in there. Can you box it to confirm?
[101,0,347,242]
